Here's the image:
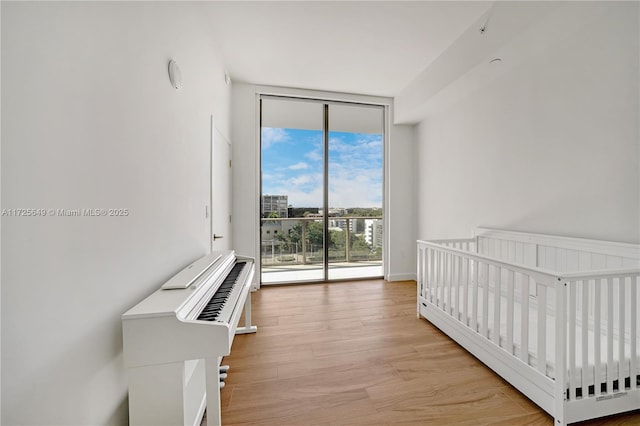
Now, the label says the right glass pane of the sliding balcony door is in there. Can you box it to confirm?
[328,105,384,279]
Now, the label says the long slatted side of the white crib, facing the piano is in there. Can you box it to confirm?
[417,240,558,364]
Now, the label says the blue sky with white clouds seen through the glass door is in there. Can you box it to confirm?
[262,127,382,207]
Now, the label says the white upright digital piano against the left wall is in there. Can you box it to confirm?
[122,251,256,426]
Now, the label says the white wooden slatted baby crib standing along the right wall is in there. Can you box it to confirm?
[417,228,640,425]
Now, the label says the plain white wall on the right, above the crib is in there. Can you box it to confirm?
[416,2,640,243]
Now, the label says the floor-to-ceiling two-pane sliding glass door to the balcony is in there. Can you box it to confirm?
[260,96,384,284]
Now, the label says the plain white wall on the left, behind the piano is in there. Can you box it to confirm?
[1,2,230,425]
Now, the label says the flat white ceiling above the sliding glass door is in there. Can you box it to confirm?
[208,1,491,96]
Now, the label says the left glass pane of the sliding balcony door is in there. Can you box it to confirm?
[260,99,324,283]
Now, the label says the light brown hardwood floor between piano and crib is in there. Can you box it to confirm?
[211,280,640,426]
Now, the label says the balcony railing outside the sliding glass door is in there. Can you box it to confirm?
[261,216,383,269]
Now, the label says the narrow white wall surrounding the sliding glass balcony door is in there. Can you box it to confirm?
[232,83,415,280]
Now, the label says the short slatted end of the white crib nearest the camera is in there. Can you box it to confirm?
[557,270,640,400]
